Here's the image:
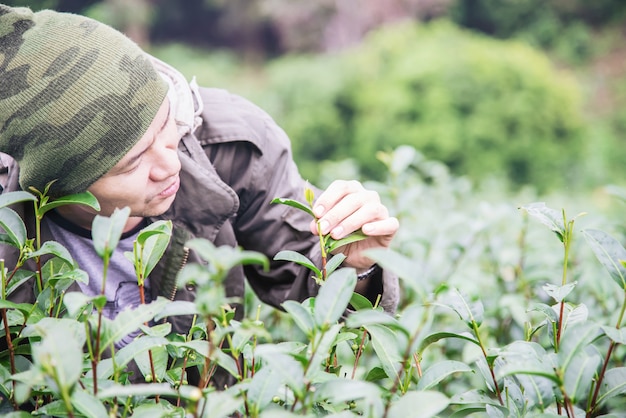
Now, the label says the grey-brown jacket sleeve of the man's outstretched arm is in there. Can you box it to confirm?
[199,89,398,311]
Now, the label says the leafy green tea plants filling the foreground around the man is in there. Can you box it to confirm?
[0,147,626,418]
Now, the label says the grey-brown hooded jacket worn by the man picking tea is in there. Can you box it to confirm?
[0,59,399,333]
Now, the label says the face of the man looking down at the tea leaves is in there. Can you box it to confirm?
[88,99,180,217]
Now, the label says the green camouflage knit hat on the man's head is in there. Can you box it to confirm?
[0,4,167,197]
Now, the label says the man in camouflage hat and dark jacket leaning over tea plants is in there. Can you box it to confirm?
[0,5,398,342]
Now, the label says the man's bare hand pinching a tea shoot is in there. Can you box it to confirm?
[311,180,399,270]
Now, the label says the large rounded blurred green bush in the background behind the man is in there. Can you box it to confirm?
[258,21,583,192]
